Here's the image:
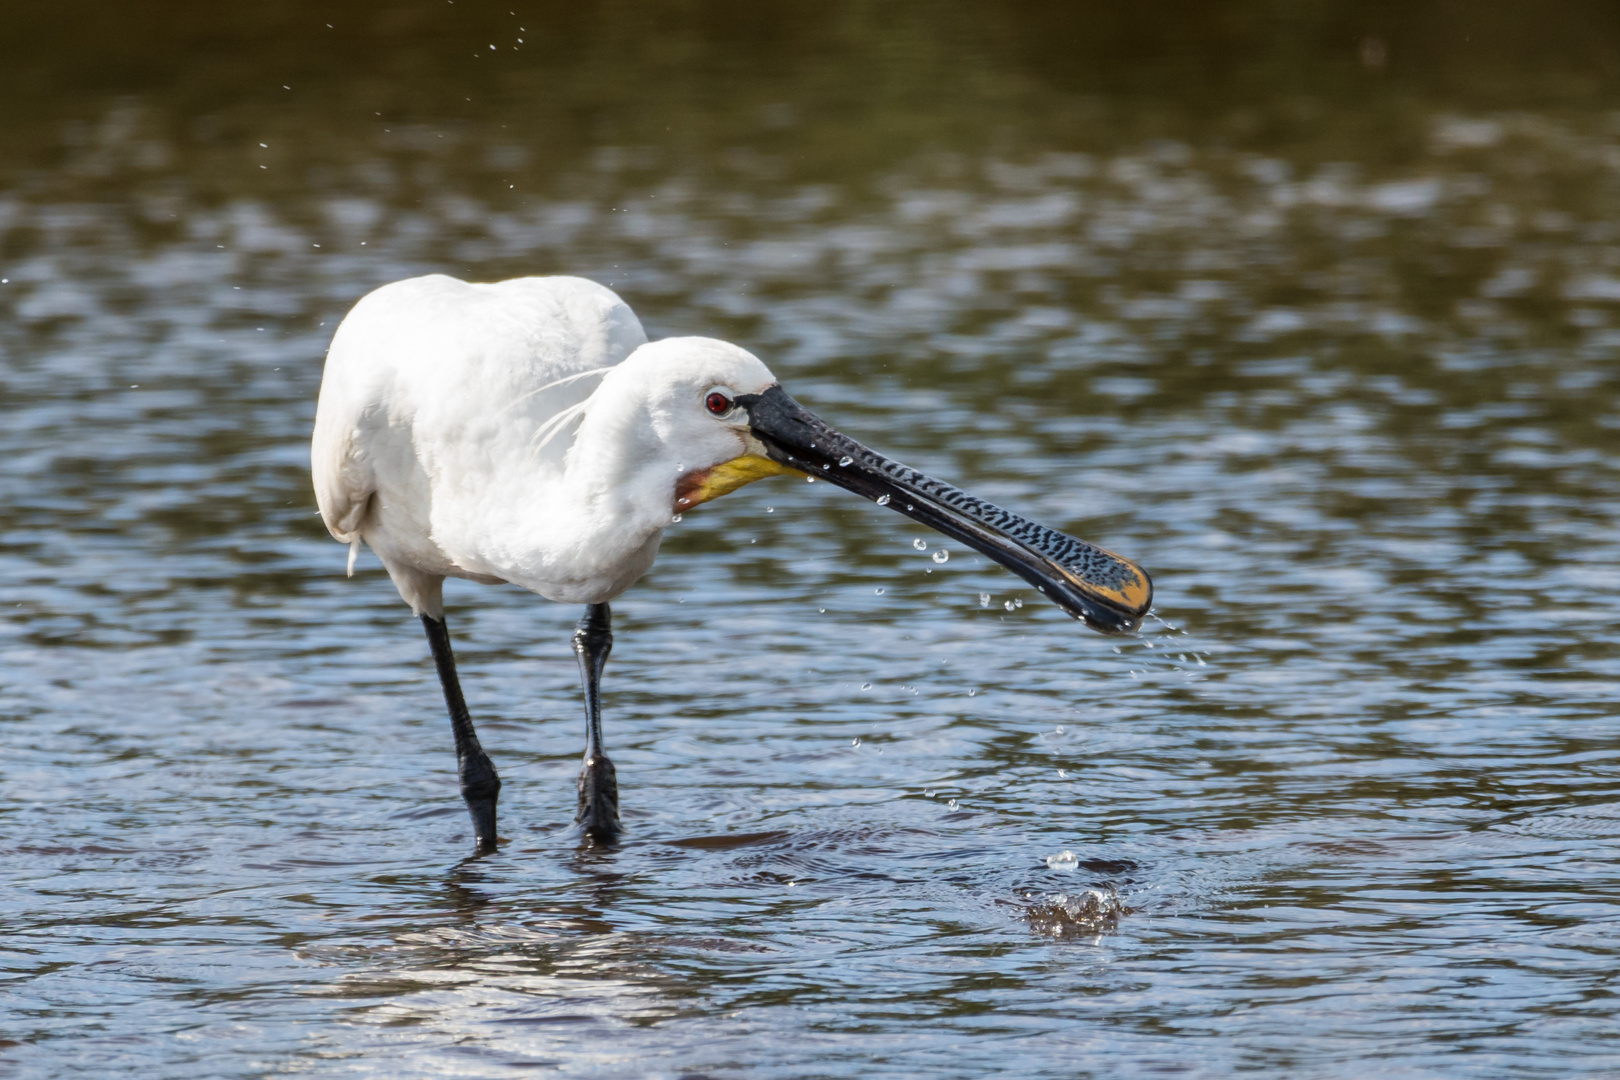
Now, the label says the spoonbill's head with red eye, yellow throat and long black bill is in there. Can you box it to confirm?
[593,338,1153,633]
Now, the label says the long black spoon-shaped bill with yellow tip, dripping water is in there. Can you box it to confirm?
[737,385,1153,633]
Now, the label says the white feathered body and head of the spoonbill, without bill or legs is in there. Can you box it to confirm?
[311,275,774,617]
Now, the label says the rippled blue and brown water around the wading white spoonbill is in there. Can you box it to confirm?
[0,5,1620,1077]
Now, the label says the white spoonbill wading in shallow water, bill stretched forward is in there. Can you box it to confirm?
[311,275,1152,850]
